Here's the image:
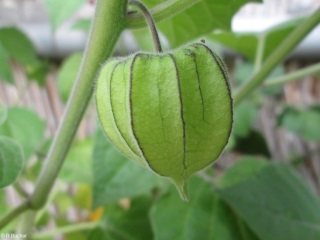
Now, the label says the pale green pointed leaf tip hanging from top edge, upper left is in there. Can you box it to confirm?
[44,0,84,29]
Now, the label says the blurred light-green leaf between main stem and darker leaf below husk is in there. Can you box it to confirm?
[59,138,93,184]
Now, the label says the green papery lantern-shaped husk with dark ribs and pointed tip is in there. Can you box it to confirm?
[96,43,233,199]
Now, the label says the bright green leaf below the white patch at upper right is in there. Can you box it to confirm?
[207,18,302,62]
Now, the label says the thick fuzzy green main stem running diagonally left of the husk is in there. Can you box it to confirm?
[15,0,128,236]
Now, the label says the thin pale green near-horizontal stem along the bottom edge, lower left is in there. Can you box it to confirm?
[33,222,100,239]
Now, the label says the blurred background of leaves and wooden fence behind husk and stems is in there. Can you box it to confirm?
[0,0,320,240]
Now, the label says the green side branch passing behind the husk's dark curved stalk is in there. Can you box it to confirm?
[126,0,202,28]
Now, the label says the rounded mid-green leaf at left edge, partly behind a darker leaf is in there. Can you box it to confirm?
[0,107,45,159]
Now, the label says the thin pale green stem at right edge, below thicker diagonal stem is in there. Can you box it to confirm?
[263,63,320,87]
